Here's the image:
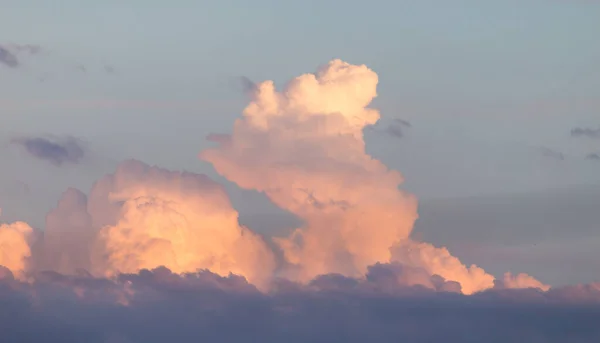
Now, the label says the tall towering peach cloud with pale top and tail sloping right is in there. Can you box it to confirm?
[200,60,536,294]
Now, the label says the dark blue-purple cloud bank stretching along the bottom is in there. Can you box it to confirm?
[0,265,600,343]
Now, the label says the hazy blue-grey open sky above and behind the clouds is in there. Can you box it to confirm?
[0,0,600,283]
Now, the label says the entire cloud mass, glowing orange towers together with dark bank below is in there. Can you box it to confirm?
[0,60,584,342]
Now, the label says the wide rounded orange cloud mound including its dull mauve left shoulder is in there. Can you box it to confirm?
[36,160,275,286]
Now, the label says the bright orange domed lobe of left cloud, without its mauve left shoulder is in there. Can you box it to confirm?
[92,161,274,284]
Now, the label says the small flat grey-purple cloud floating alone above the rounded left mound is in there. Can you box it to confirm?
[12,137,86,166]
